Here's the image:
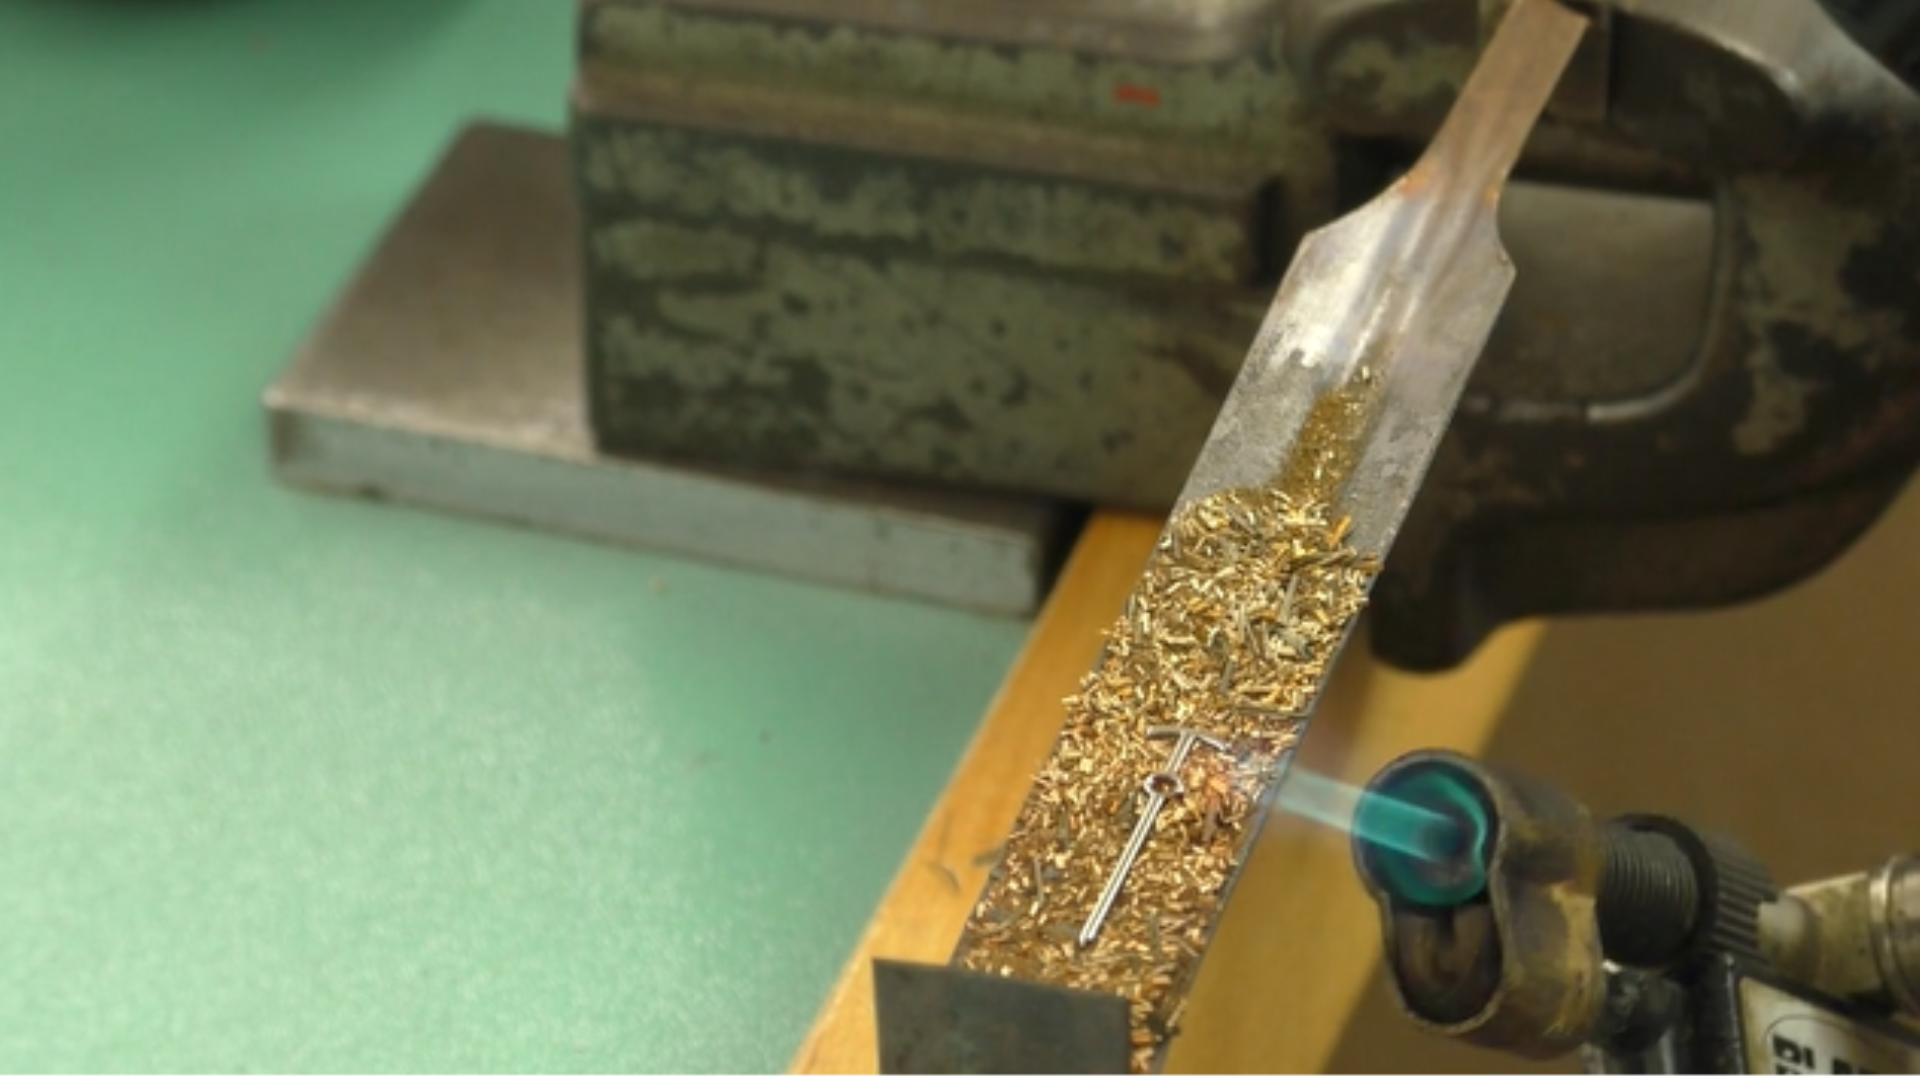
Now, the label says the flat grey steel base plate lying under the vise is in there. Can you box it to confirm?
[267,125,1069,615]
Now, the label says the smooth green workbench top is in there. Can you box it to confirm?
[0,0,1025,1072]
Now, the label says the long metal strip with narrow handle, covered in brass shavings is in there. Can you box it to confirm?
[876,0,1588,1072]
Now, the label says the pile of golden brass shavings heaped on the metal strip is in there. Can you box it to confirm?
[954,490,1379,1072]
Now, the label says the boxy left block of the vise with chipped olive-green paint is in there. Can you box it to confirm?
[576,0,1332,509]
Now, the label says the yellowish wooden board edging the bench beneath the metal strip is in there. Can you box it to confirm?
[791,513,1540,1074]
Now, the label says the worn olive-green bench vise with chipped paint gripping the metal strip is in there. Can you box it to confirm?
[576,0,1920,669]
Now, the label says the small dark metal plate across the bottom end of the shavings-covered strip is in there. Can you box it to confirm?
[874,961,1127,1076]
